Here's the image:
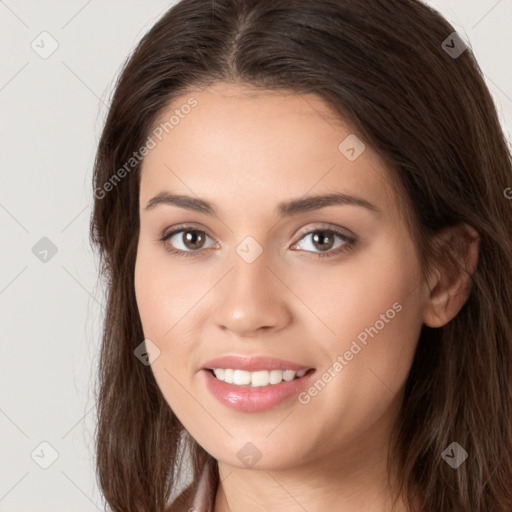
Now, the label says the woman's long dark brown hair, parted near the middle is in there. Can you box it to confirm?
[90,0,512,512]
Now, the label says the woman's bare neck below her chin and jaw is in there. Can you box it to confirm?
[214,432,407,512]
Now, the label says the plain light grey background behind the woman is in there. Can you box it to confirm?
[0,0,512,512]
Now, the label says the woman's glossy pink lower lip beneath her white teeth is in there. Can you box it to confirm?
[203,370,315,412]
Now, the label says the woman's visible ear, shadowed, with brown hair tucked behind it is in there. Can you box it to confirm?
[423,224,480,327]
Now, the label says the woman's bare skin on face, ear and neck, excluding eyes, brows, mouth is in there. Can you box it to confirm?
[135,83,477,512]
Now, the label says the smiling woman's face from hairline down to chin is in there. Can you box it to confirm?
[135,84,428,469]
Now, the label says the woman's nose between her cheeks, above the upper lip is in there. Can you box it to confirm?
[214,253,292,337]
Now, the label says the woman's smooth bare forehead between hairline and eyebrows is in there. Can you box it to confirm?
[141,84,393,216]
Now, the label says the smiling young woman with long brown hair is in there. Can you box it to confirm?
[91,0,512,512]
